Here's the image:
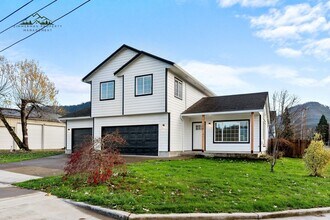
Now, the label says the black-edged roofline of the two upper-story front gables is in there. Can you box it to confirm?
[82,44,174,82]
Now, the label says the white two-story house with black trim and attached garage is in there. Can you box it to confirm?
[63,45,269,156]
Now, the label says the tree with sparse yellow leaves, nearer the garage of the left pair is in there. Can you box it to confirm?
[9,60,58,149]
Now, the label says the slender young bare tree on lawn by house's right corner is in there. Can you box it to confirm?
[270,90,299,172]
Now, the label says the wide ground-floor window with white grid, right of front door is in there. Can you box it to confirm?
[214,120,249,143]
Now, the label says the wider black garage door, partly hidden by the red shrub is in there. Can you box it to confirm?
[102,125,158,156]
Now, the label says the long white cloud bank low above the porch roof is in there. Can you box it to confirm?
[180,61,330,94]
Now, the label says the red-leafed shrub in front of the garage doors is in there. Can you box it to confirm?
[64,131,126,184]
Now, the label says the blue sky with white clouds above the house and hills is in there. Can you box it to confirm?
[0,0,330,105]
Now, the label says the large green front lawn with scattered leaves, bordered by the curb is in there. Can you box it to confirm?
[17,158,330,213]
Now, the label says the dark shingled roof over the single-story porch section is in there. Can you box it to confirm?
[182,92,268,114]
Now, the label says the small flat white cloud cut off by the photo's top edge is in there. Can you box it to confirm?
[218,0,279,8]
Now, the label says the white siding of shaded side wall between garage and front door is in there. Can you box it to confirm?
[167,71,205,151]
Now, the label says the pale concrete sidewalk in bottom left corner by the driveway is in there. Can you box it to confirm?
[0,170,111,220]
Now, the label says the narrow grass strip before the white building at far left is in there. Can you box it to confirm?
[0,150,64,164]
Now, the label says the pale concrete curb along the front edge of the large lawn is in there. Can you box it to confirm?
[64,199,330,220]
